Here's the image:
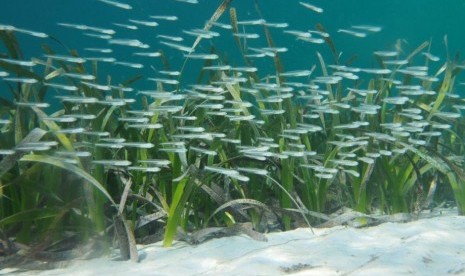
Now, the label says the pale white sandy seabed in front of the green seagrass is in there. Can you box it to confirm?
[0,210,465,276]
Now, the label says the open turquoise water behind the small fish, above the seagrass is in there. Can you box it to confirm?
[0,0,465,91]
